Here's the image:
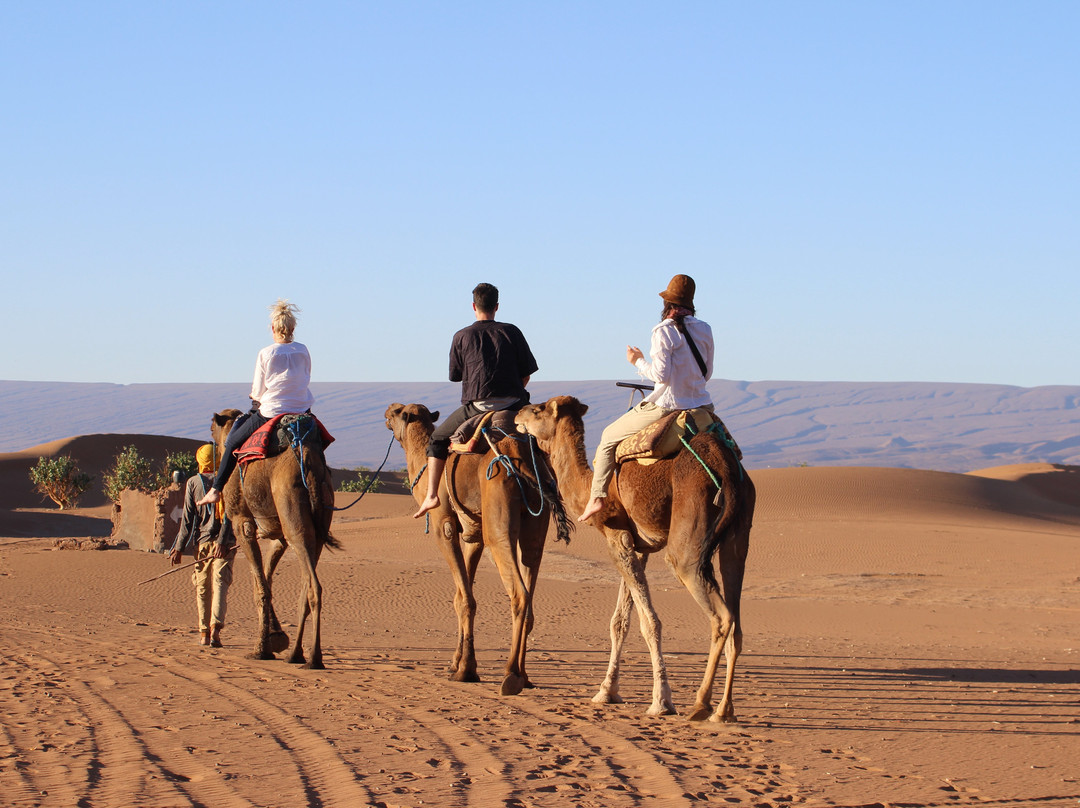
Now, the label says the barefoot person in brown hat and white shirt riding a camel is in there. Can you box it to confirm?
[578,274,713,522]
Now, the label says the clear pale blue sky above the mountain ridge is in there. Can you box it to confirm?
[0,0,1080,386]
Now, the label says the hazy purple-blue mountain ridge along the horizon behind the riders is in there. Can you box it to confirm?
[0,379,1080,472]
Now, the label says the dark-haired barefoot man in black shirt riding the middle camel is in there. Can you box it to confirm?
[413,283,538,519]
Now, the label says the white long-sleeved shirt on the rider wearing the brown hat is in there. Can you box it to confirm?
[634,317,713,409]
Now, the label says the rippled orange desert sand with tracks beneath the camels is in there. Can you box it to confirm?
[0,439,1080,808]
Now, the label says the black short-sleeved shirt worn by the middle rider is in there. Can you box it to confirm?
[450,320,537,404]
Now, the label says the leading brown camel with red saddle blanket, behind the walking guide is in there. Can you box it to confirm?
[211,409,338,669]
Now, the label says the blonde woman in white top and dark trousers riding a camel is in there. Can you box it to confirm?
[197,300,315,506]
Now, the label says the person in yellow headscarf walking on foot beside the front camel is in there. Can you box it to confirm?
[170,443,237,648]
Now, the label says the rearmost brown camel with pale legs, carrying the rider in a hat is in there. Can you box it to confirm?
[516,395,755,722]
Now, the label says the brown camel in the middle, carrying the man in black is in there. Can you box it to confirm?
[386,404,569,696]
